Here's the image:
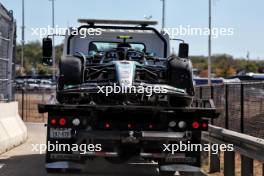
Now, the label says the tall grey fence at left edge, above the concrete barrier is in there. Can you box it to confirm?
[0,3,16,101]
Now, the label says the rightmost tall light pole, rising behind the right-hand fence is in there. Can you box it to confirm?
[208,0,212,85]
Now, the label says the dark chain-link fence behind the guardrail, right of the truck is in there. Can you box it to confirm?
[196,82,264,138]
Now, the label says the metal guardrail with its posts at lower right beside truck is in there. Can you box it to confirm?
[203,125,264,176]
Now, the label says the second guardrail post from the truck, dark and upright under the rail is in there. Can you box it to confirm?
[224,151,235,176]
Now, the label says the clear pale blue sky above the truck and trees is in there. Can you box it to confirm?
[1,0,264,59]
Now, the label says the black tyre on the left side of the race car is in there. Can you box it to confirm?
[60,56,82,85]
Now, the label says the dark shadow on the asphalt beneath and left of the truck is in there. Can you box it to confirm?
[0,154,158,176]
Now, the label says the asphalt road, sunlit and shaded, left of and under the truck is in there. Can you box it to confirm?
[0,123,206,176]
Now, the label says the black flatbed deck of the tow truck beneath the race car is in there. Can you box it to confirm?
[38,100,220,119]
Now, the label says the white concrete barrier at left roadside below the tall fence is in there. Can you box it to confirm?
[0,102,27,154]
